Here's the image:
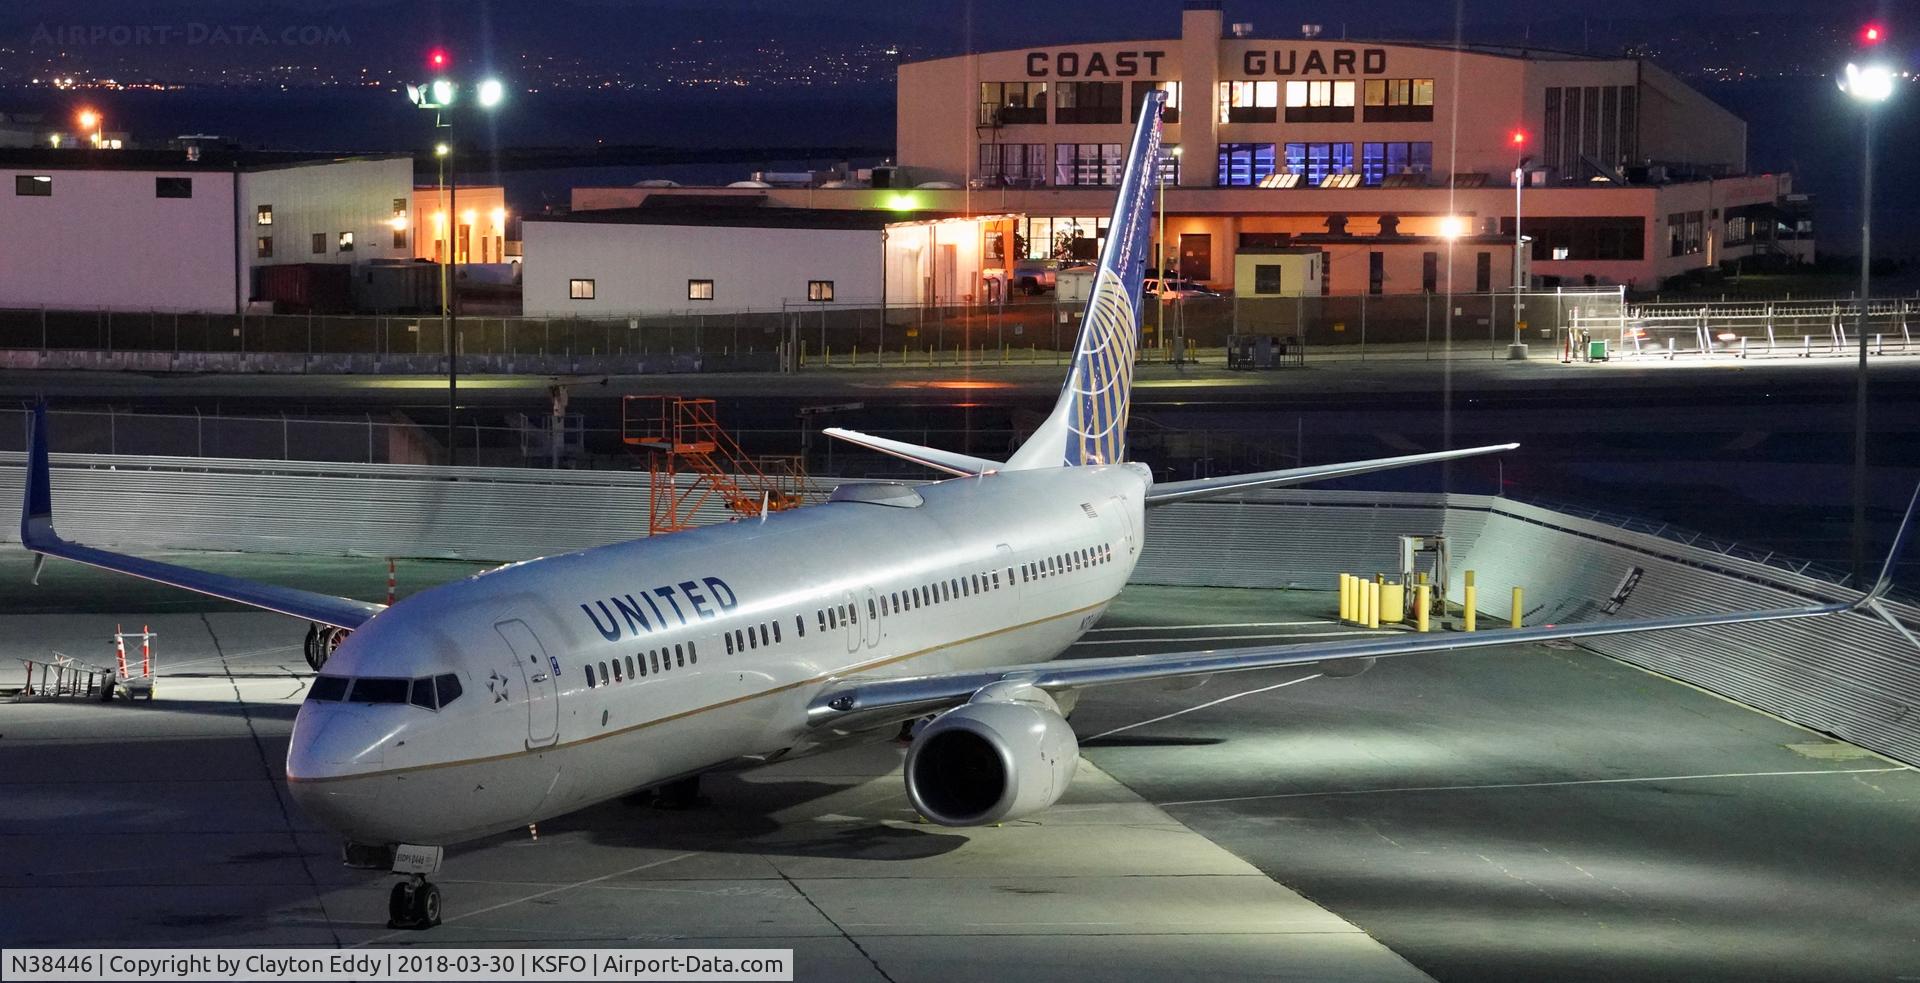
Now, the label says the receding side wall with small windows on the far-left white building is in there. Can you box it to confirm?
[240,157,415,288]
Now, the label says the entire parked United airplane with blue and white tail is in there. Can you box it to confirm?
[21,92,1912,927]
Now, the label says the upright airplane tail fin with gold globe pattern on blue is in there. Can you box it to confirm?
[1006,92,1167,470]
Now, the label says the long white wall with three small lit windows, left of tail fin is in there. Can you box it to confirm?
[520,219,881,317]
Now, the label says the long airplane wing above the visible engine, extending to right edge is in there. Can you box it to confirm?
[806,481,1920,731]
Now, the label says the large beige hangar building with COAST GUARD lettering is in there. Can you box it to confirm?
[574,0,1812,294]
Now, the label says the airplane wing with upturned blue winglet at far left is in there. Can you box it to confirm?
[19,405,386,628]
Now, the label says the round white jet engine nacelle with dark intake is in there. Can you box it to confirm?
[906,683,1079,826]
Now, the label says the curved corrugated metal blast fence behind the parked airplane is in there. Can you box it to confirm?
[0,453,1920,762]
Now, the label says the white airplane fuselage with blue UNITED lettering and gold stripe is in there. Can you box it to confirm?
[286,465,1150,845]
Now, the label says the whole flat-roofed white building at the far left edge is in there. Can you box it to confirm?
[0,148,413,311]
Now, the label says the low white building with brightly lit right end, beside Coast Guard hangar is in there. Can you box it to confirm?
[520,196,1012,317]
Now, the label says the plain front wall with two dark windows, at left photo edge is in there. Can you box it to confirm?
[0,169,234,311]
